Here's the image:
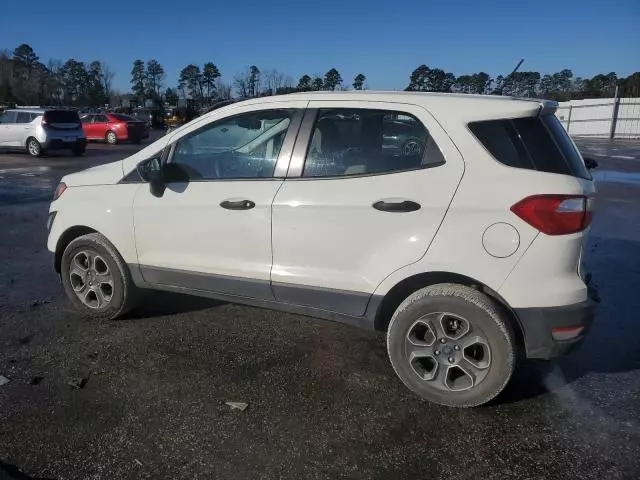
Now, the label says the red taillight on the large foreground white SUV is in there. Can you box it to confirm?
[511,195,594,235]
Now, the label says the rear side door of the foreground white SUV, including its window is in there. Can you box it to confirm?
[271,101,463,316]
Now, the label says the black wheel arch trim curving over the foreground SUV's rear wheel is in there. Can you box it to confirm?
[374,272,524,347]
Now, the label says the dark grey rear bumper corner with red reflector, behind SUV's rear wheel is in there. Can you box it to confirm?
[514,299,595,359]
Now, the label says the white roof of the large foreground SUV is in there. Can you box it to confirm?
[228,90,558,121]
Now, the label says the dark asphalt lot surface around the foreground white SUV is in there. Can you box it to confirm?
[0,136,640,479]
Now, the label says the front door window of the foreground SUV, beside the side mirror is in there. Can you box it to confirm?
[167,109,295,181]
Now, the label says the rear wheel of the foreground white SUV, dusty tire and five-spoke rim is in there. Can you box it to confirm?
[387,284,516,408]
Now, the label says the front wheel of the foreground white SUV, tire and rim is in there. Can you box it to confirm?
[60,233,139,320]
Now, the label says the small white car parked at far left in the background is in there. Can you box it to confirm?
[0,108,87,157]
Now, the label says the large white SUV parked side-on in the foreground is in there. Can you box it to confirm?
[48,92,595,407]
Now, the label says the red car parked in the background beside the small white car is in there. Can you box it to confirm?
[80,113,149,145]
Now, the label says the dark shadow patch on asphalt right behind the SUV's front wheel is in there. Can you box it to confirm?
[127,291,225,320]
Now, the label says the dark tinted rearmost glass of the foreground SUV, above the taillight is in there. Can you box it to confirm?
[469,115,591,178]
